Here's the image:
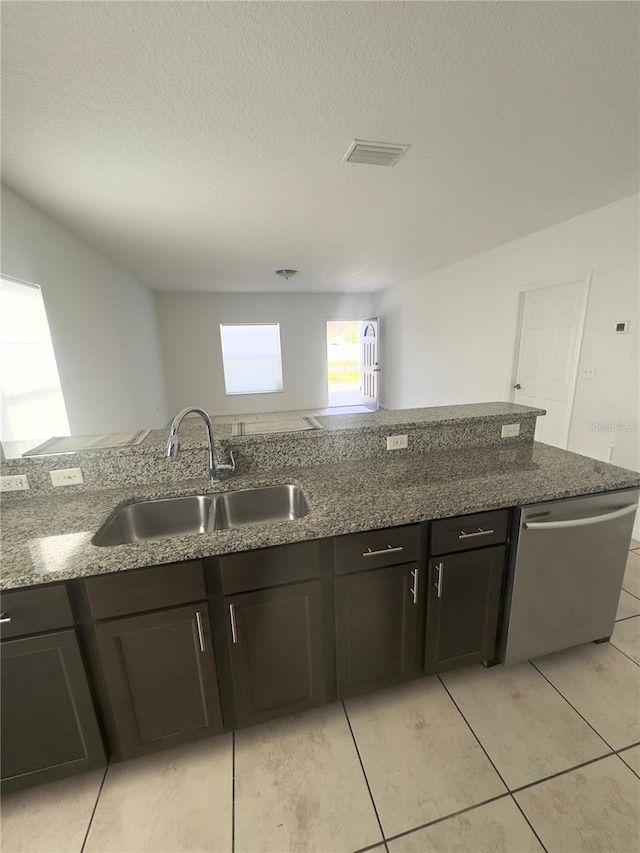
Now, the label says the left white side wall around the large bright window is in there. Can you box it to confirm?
[2,187,169,435]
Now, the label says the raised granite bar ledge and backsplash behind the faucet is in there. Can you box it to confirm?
[2,402,544,504]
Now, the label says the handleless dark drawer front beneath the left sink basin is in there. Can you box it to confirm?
[84,560,206,619]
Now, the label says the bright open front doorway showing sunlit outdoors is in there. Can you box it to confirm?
[327,320,362,408]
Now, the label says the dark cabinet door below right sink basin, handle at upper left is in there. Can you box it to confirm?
[225,581,325,727]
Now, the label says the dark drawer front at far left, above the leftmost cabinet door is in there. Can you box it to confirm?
[0,584,73,640]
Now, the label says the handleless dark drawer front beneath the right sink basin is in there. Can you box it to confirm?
[220,541,320,595]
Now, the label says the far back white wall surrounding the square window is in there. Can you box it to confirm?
[157,293,373,415]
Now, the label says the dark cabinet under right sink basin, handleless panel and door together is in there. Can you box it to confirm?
[207,540,335,728]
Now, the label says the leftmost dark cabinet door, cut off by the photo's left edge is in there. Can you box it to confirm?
[1,630,106,792]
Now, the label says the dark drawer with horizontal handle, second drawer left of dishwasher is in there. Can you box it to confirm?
[334,524,421,575]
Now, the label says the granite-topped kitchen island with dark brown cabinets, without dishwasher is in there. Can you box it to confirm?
[2,403,640,790]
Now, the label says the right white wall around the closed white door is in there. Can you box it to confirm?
[376,196,640,470]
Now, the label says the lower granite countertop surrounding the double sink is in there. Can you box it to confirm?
[1,442,640,589]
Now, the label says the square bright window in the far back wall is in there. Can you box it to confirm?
[220,323,283,394]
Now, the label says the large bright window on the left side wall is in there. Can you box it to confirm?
[0,278,70,441]
